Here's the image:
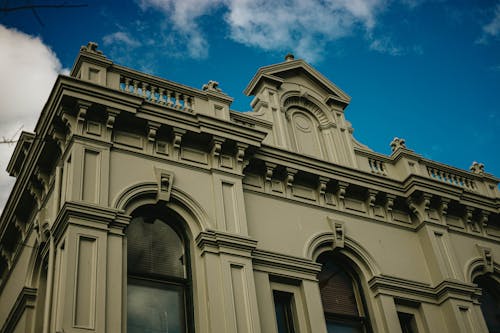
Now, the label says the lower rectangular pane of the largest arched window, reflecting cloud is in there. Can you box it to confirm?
[127,281,185,333]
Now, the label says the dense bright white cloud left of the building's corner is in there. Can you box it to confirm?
[0,25,67,211]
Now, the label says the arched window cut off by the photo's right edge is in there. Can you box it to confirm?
[474,275,500,333]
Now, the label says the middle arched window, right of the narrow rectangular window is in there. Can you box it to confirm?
[317,252,371,333]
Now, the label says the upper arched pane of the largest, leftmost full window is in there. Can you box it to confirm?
[127,218,185,278]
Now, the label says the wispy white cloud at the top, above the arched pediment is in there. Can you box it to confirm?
[139,0,386,62]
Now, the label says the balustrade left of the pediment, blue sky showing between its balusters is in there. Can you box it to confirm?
[120,75,194,112]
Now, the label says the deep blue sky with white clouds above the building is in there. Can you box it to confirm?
[0,0,500,209]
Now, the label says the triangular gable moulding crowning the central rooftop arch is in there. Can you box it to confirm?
[244,59,351,105]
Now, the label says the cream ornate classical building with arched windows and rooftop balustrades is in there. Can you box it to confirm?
[0,43,500,333]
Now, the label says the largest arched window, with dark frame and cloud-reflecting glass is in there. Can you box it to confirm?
[127,206,192,333]
